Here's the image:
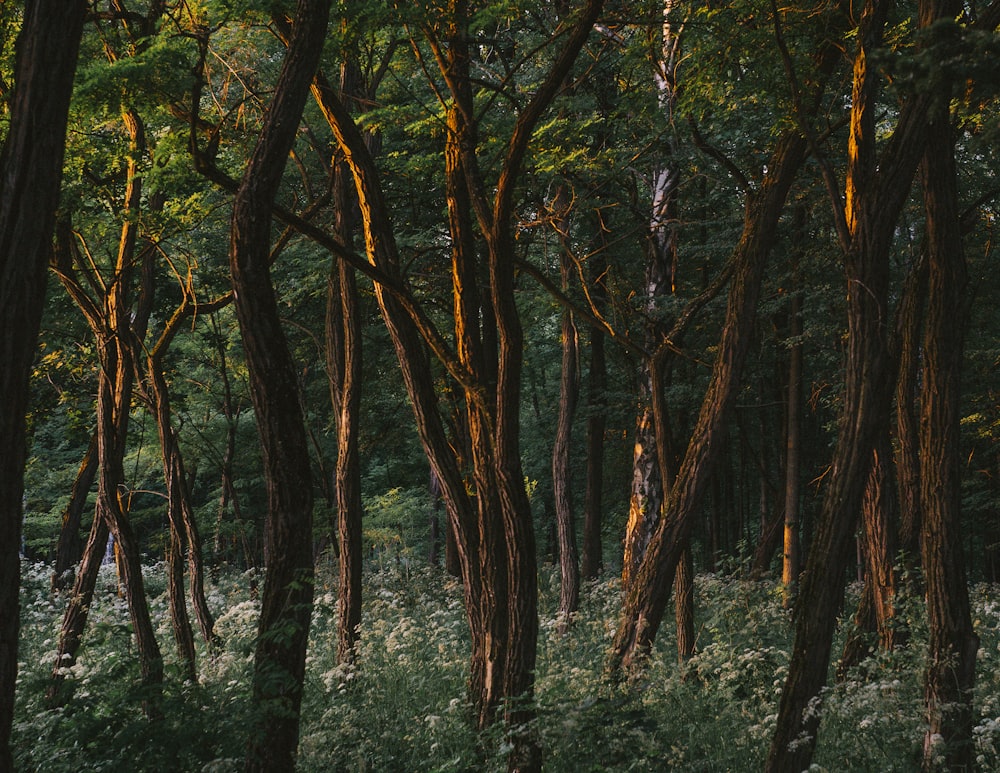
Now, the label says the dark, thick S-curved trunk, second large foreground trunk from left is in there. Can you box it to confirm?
[229,0,330,772]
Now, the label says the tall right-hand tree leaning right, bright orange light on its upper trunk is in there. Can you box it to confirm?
[767,0,946,771]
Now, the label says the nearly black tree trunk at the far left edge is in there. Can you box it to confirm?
[0,0,87,770]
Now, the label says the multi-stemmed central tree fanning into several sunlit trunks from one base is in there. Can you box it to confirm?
[290,0,600,770]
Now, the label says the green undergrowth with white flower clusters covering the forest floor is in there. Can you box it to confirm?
[14,564,1000,773]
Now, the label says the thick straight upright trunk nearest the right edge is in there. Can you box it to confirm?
[920,77,979,771]
